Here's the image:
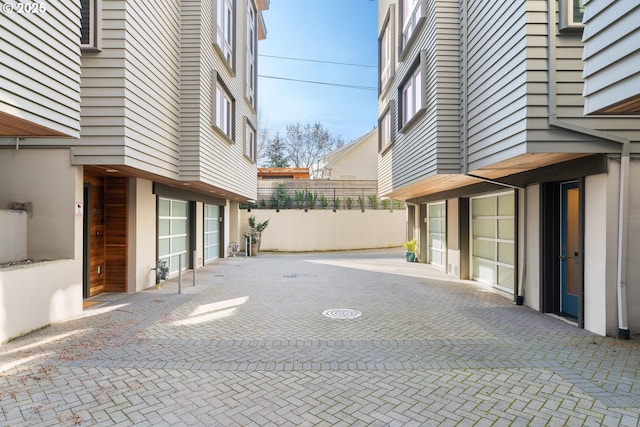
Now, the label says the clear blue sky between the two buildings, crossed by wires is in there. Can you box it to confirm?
[258,0,378,142]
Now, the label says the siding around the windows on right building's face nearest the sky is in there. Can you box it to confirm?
[378,0,460,194]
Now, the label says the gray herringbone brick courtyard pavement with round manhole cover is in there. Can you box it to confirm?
[0,249,640,426]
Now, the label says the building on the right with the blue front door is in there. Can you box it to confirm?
[378,0,640,337]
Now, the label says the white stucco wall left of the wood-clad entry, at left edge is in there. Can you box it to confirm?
[0,149,83,342]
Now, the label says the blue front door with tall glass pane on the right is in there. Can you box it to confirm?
[560,181,581,318]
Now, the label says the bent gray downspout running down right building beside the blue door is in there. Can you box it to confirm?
[547,1,631,339]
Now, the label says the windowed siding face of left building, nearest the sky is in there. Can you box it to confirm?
[180,0,257,199]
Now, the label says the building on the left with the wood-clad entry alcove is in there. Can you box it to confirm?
[0,0,269,341]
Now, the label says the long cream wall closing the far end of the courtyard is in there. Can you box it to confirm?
[240,209,406,252]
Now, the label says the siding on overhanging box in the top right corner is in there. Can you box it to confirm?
[583,0,640,114]
